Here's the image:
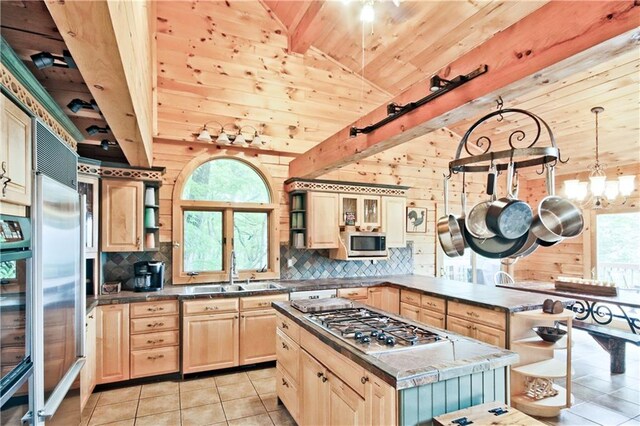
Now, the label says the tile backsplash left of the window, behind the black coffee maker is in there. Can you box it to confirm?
[102,243,173,287]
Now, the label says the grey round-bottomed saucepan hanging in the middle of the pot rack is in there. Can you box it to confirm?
[487,160,533,240]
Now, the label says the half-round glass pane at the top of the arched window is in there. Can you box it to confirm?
[182,158,271,203]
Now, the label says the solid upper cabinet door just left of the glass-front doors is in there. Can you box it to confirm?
[307,192,340,249]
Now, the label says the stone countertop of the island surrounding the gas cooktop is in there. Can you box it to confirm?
[273,302,519,390]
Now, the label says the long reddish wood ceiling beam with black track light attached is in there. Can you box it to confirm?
[289,1,640,178]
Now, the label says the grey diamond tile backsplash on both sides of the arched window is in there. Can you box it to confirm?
[103,242,413,287]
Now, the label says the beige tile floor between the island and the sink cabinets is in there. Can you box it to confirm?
[82,367,295,426]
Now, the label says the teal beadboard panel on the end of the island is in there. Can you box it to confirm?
[398,367,507,426]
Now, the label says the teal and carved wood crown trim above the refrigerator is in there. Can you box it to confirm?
[0,36,84,150]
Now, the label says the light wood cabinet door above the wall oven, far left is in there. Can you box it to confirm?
[0,95,32,206]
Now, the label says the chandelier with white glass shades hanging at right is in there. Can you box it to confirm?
[564,107,636,209]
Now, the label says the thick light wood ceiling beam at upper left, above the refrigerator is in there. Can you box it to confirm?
[46,0,152,167]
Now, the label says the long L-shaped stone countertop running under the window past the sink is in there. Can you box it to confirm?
[87,275,575,312]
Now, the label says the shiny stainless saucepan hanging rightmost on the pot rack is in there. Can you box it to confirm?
[531,167,584,243]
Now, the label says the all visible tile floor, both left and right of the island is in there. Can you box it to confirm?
[82,331,640,426]
